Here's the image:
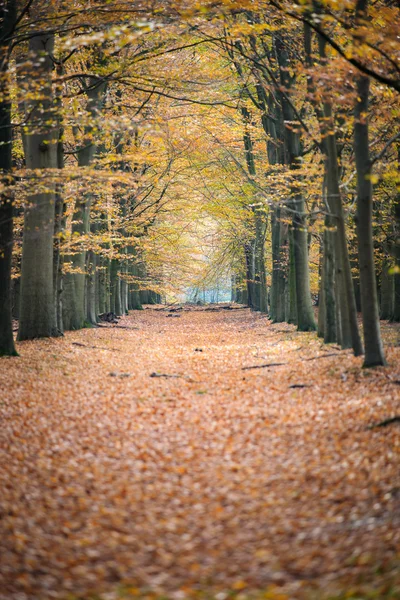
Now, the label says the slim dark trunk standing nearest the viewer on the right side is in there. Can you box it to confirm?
[354,76,386,367]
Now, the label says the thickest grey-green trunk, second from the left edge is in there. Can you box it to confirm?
[18,34,59,340]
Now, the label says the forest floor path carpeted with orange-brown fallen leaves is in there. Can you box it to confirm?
[0,308,400,600]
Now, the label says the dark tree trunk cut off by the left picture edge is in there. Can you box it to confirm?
[0,0,17,356]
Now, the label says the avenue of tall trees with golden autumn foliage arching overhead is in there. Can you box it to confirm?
[0,0,400,367]
